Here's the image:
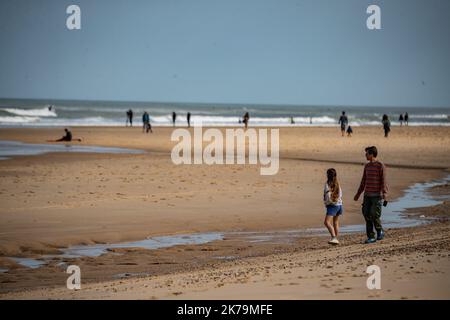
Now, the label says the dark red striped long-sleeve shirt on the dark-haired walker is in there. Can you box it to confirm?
[357,161,388,197]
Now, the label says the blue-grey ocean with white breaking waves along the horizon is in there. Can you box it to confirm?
[0,99,450,127]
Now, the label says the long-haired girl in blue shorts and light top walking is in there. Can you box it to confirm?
[323,168,344,244]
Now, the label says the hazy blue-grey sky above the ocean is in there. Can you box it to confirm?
[0,0,450,107]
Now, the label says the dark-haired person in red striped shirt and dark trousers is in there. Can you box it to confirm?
[354,146,388,243]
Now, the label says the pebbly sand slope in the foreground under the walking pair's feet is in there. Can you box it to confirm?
[0,203,450,300]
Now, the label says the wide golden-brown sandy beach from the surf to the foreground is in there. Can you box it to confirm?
[0,127,450,299]
